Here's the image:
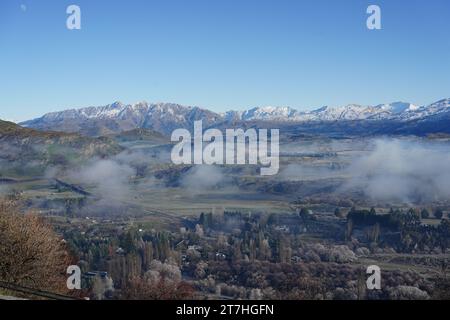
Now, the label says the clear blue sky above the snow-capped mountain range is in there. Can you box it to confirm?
[0,0,450,121]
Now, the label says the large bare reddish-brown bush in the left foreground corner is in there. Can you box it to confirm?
[0,200,71,294]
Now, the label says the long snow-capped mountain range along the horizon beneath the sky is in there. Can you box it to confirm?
[22,99,450,136]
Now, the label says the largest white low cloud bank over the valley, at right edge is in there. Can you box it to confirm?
[344,139,450,202]
